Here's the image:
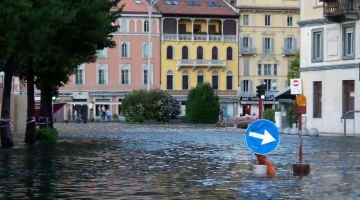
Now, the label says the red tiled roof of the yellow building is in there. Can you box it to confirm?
[155,0,239,18]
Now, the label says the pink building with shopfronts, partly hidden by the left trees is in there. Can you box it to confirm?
[21,0,161,120]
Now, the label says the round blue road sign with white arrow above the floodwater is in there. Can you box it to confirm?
[245,119,280,155]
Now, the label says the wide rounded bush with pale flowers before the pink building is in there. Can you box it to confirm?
[121,89,180,122]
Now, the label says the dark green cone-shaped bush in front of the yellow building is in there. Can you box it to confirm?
[186,83,220,124]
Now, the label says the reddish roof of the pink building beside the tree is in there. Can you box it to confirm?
[110,0,160,15]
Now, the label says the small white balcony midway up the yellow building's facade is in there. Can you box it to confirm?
[176,59,226,71]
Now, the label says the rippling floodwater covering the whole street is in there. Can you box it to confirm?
[0,123,360,200]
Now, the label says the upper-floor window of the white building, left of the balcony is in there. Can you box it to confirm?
[311,28,324,62]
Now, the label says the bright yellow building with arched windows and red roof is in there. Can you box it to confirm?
[156,0,239,116]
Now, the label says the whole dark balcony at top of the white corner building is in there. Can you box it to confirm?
[323,0,360,23]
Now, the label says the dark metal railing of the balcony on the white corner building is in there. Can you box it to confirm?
[323,0,360,17]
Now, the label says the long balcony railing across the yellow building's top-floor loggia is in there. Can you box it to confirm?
[161,34,238,42]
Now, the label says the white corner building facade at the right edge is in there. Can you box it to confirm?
[298,0,360,134]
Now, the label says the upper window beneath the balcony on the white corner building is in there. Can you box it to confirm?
[343,24,355,59]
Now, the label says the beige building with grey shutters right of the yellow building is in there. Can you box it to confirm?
[236,0,300,114]
